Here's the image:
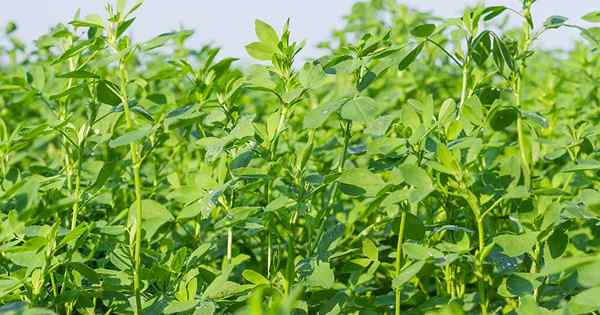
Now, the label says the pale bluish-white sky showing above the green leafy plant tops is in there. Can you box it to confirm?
[0,0,600,60]
